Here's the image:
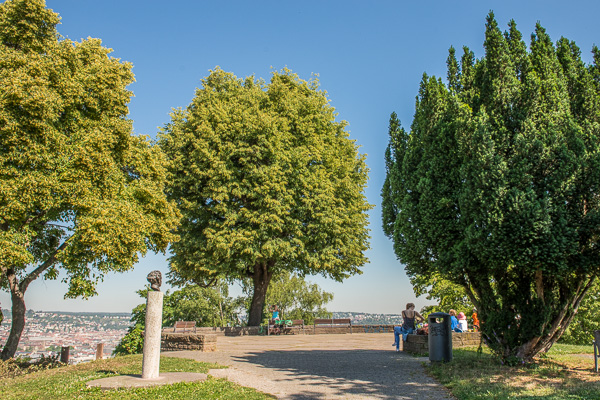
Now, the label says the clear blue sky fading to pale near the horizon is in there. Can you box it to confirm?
[0,0,600,313]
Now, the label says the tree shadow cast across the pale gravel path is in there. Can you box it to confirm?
[232,350,451,400]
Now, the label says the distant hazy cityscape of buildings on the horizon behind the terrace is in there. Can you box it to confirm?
[0,309,402,364]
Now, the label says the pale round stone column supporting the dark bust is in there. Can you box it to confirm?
[142,290,163,379]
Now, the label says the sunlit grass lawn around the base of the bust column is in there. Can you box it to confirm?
[0,355,273,400]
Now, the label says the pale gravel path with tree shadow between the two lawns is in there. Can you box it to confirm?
[162,333,453,400]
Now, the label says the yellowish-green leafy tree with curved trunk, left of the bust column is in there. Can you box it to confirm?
[0,0,178,359]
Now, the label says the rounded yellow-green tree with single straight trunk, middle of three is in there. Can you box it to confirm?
[159,68,371,325]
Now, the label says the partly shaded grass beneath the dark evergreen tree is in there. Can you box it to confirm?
[426,344,600,400]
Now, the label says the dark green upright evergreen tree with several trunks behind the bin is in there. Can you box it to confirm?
[382,13,600,360]
